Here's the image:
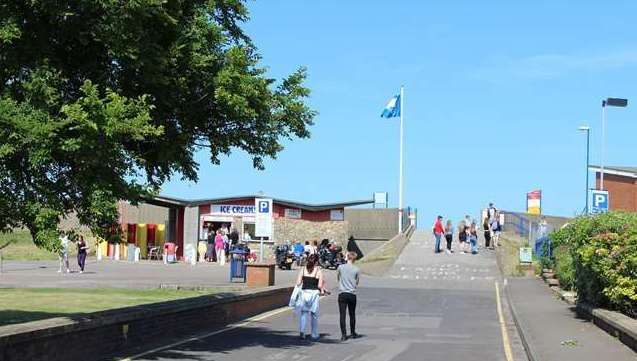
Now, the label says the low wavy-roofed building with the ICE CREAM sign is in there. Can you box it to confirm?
[135,195,372,260]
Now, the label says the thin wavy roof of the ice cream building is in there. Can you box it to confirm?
[146,194,374,212]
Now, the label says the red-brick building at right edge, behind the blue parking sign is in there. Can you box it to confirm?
[590,166,637,212]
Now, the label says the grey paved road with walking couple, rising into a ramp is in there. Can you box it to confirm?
[117,232,520,361]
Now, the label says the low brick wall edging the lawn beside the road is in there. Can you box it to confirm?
[0,287,292,361]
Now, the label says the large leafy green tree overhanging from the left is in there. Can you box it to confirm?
[0,0,315,251]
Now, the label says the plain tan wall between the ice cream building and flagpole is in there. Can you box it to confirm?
[345,208,398,240]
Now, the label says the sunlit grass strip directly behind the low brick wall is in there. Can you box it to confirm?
[0,288,232,326]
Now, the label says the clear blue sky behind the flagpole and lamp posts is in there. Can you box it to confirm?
[163,0,637,223]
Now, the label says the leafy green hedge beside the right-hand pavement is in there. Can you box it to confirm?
[551,212,637,317]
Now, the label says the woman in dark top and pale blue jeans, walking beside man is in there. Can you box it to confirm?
[294,254,327,341]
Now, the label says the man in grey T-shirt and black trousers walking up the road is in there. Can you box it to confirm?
[336,252,360,341]
